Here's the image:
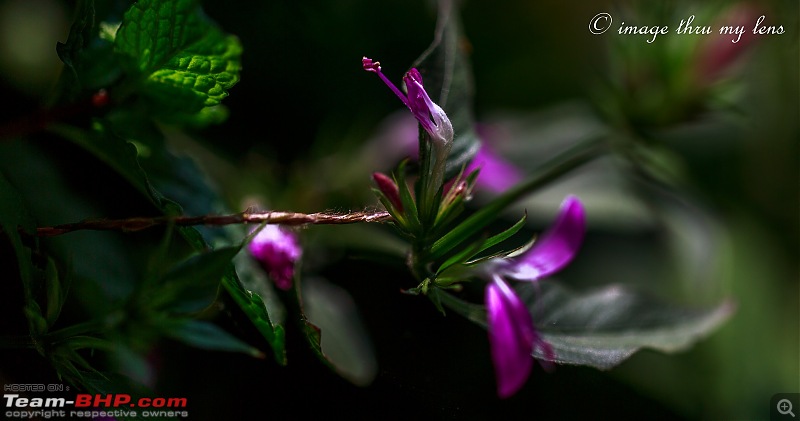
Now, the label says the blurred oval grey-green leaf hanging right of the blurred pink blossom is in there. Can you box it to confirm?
[298,278,378,386]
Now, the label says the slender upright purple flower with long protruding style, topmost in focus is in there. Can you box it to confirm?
[361,57,454,148]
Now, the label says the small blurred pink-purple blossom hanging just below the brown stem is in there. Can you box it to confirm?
[247,225,302,291]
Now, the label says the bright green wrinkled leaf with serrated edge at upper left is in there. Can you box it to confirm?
[114,0,242,125]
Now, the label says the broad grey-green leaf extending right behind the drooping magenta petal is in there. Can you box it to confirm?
[517,282,734,370]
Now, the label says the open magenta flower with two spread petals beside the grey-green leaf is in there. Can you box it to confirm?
[485,196,586,398]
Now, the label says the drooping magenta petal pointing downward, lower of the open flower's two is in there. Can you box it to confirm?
[486,276,537,398]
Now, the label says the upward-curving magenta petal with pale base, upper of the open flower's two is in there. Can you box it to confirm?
[502,196,586,281]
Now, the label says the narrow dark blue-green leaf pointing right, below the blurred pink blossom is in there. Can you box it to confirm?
[163,319,264,358]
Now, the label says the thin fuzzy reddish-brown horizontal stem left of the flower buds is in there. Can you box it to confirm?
[21,211,392,237]
